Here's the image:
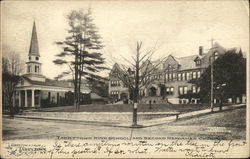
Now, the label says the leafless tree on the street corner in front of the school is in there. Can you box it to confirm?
[113,42,165,127]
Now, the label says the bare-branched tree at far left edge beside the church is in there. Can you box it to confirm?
[2,52,24,116]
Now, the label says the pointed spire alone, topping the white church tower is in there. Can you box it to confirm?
[29,21,40,56]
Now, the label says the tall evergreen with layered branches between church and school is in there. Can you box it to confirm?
[54,9,106,111]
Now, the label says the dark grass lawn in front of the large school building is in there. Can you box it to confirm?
[34,104,229,113]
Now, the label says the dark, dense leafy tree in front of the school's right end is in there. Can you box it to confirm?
[190,49,246,109]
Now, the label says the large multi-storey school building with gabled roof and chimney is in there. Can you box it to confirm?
[109,43,245,104]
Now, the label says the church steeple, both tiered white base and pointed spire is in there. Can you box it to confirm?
[26,21,45,82]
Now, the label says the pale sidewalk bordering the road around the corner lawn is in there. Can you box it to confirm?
[8,104,246,128]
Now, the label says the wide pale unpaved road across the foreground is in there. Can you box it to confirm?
[3,108,246,140]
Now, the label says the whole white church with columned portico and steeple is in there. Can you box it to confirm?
[15,22,91,108]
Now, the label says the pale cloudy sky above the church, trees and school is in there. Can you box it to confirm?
[1,0,249,78]
